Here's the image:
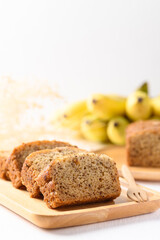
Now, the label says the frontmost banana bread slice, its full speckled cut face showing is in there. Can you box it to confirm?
[36,150,121,208]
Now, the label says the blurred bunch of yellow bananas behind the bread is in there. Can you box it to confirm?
[52,83,160,145]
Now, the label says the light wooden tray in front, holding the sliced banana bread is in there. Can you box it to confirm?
[0,179,160,228]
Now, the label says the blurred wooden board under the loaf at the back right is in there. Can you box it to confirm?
[96,146,160,181]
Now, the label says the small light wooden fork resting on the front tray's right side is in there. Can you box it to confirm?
[122,165,148,202]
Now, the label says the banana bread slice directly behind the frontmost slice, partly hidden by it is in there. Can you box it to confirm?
[21,147,83,197]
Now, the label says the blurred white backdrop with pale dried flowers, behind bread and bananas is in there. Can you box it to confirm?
[0,0,160,148]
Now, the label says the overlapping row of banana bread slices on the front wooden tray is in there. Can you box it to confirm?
[0,141,121,208]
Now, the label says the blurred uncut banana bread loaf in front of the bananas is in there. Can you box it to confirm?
[126,120,160,167]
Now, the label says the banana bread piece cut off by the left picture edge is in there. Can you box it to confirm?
[0,151,10,180]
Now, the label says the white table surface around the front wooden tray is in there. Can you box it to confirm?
[0,182,160,240]
